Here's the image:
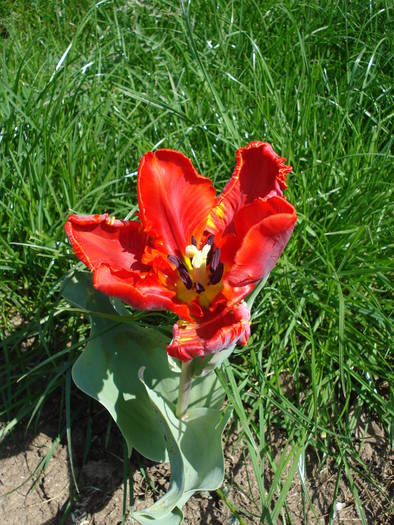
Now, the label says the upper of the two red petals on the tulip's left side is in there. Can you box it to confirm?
[65,213,149,272]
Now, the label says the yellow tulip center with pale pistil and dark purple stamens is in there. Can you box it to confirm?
[168,235,224,307]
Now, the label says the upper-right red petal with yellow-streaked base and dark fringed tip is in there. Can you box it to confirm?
[207,142,292,234]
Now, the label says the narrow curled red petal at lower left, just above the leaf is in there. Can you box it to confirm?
[93,264,192,321]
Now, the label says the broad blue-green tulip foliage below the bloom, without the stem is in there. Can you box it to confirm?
[63,273,229,525]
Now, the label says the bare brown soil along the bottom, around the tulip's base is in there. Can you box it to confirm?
[0,404,393,525]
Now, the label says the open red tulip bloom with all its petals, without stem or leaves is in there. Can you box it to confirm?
[65,142,297,361]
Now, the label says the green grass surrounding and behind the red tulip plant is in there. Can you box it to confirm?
[0,0,393,523]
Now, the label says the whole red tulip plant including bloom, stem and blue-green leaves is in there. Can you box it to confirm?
[63,142,297,525]
